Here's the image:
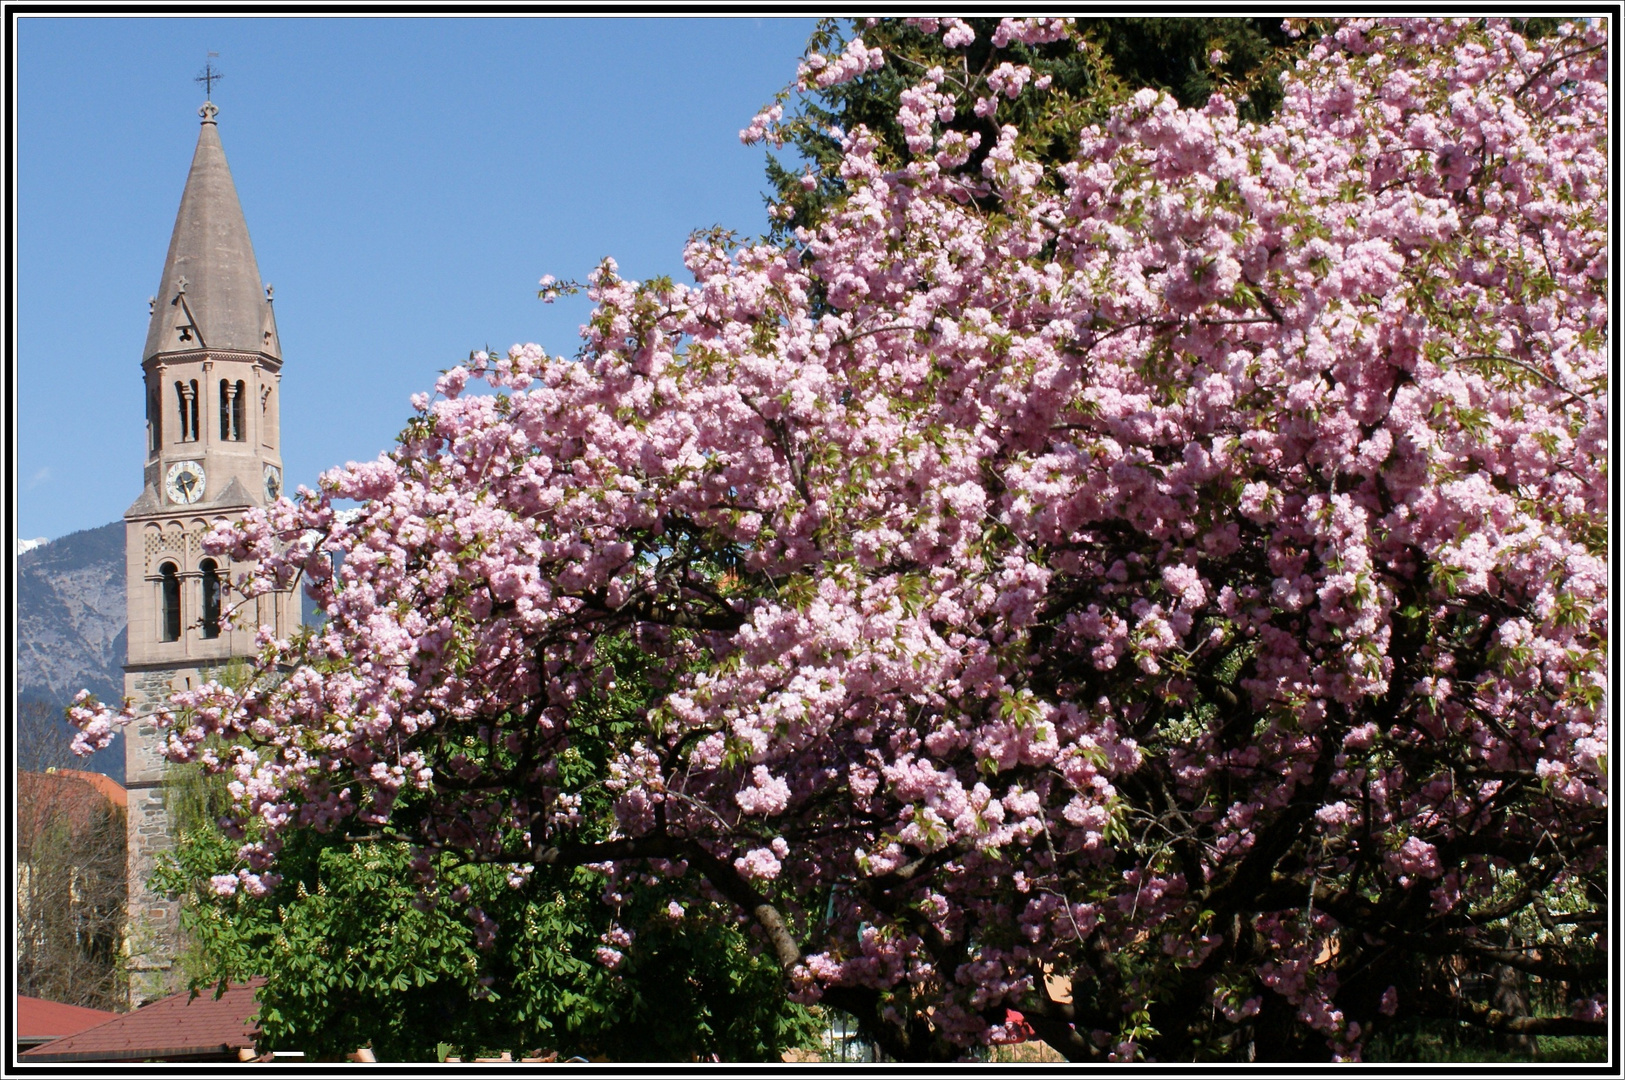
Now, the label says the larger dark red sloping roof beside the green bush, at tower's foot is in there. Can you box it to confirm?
[20,979,265,1061]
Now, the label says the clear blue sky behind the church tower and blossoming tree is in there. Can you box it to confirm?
[13,16,825,538]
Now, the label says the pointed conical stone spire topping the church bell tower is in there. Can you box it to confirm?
[141,102,281,361]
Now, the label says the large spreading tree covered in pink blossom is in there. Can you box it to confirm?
[76,19,1609,1061]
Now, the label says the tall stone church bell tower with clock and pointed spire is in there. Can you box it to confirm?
[124,102,299,1005]
